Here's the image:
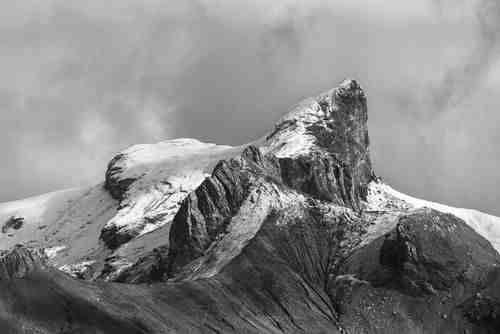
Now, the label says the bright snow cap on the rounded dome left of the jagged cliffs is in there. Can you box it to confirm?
[102,138,241,240]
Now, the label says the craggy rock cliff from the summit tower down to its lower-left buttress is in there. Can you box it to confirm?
[158,81,373,276]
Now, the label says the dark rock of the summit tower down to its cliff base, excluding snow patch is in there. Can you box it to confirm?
[268,80,375,210]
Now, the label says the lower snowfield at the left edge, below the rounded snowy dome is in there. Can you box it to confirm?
[0,184,118,271]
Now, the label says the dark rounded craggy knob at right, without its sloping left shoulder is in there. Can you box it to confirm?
[380,210,497,291]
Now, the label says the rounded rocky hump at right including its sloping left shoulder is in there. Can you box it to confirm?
[342,209,500,295]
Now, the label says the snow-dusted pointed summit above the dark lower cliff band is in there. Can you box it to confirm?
[263,79,374,206]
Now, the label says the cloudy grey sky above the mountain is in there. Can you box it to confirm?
[0,0,500,215]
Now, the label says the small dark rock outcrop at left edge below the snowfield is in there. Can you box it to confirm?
[0,245,47,280]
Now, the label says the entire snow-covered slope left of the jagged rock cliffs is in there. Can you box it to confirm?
[0,139,241,276]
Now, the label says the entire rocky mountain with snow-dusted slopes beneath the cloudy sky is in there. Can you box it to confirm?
[0,80,500,333]
